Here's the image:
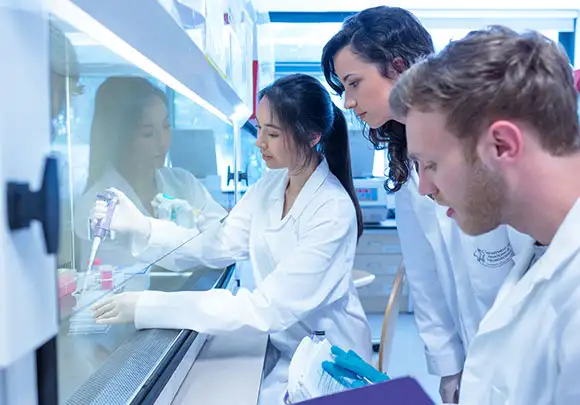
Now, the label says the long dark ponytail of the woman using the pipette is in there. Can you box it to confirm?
[321,103,363,238]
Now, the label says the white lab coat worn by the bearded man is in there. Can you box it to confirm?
[460,199,580,405]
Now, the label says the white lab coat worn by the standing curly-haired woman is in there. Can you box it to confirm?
[395,172,533,376]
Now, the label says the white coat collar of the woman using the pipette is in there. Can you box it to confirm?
[268,159,330,226]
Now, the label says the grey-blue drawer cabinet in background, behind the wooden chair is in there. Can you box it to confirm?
[354,219,412,313]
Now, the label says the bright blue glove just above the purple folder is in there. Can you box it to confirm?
[322,346,389,388]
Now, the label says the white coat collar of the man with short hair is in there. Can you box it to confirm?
[479,199,580,334]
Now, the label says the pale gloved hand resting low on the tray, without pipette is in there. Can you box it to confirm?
[91,291,141,324]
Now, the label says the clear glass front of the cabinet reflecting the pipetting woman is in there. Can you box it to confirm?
[49,14,233,404]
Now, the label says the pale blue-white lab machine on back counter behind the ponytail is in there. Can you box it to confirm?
[353,177,388,224]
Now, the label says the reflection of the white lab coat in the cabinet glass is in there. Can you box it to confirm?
[74,167,227,270]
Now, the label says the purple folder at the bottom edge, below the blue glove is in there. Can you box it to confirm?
[300,377,435,405]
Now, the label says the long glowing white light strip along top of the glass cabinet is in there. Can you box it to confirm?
[50,0,235,125]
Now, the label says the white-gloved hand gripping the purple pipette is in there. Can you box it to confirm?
[89,188,151,240]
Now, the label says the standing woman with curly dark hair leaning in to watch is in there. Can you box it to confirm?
[322,6,527,403]
